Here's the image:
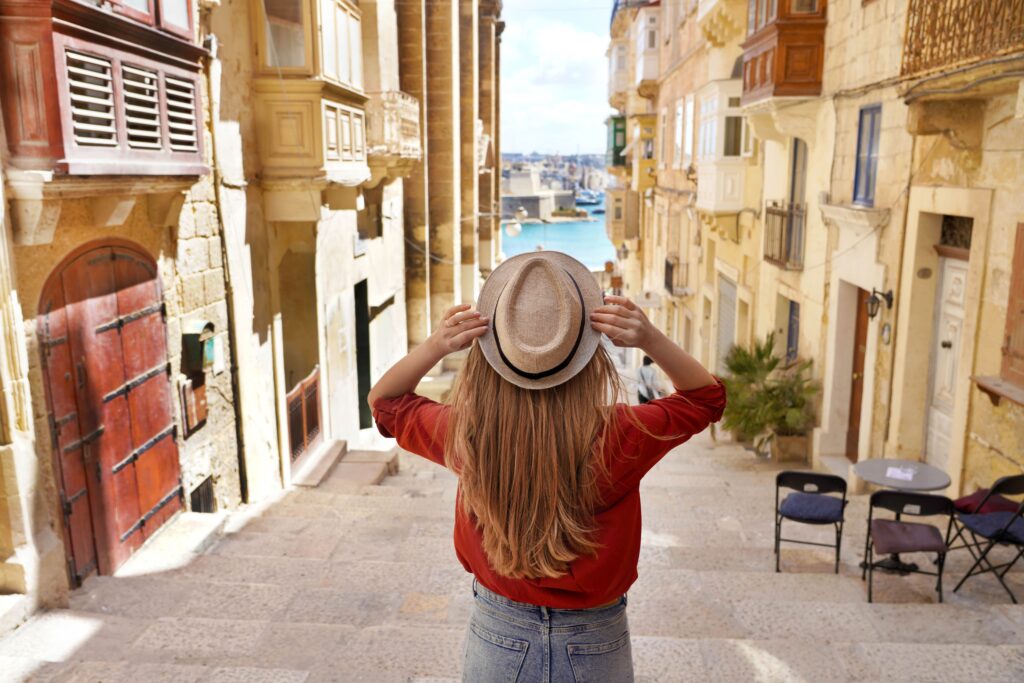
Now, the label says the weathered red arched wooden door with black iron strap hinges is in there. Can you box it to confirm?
[38,241,181,584]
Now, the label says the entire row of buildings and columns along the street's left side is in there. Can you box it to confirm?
[0,0,502,626]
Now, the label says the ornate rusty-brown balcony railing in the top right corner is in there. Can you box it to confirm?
[902,0,1024,75]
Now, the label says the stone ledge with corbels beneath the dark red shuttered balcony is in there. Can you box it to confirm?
[7,169,198,246]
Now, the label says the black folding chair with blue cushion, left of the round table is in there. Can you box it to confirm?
[775,471,847,573]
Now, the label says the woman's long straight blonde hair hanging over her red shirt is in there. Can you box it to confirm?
[444,344,622,579]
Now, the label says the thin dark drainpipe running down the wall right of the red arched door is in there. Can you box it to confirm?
[203,30,249,503]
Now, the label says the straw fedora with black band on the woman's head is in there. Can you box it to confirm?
[476,251,604,389]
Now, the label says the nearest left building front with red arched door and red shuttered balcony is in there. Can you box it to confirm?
[0,0,242,609]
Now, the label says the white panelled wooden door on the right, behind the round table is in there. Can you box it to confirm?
[925,258,968,470]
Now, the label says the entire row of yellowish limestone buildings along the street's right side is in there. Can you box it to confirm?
[608,0,1024,495]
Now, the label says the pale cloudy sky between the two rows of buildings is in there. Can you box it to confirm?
[501,0,612,154]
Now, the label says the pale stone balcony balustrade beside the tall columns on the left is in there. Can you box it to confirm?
[367,90,423,161]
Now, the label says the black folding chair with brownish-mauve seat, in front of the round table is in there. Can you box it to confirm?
[860,490,955,602]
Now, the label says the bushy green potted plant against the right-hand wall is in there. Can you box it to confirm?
[722,334,818,462]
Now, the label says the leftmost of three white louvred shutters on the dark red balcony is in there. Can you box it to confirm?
[65,50,118,146]
